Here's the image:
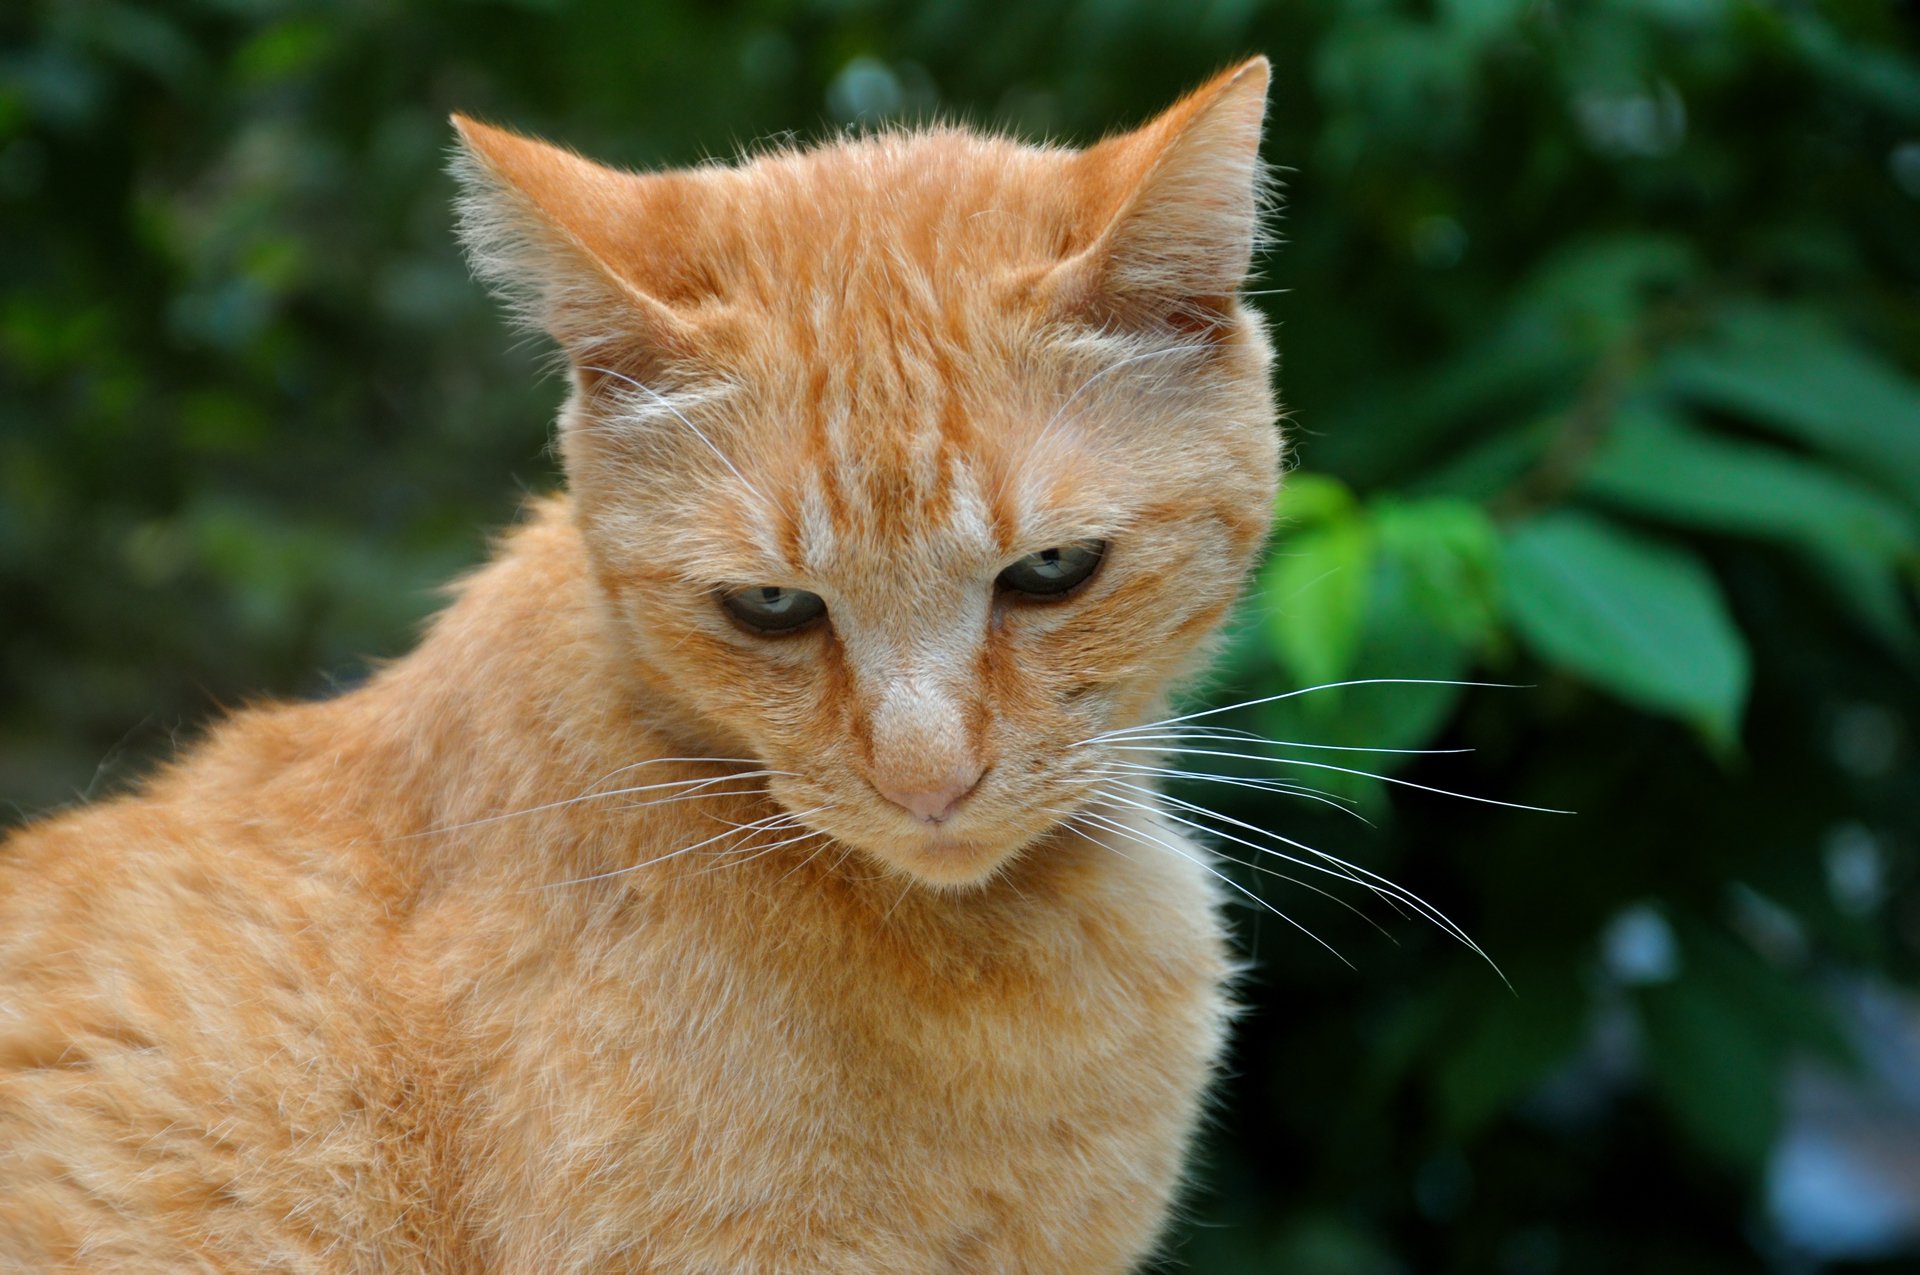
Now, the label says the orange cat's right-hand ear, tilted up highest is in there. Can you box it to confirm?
[1041,58,1269,332]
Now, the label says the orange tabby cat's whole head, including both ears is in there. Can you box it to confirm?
[455,60,1279,885]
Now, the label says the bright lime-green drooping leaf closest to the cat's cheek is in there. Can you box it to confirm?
[1261,517,1373,684]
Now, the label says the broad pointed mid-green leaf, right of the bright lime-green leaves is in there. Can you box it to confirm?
[1503,511,1749,745]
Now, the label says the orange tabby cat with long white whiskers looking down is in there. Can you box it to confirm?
[0,60,1279,1273]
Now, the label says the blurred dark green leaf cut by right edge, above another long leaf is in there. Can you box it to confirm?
[1665,305,1920,507]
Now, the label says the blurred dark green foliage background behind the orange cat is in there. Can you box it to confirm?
[0,0,1920,1275]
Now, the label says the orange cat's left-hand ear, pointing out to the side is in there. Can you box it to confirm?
[453,115,701,378]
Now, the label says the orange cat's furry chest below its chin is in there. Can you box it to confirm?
[445,821,1225,1271]
